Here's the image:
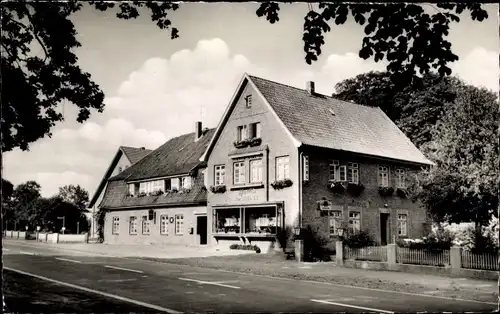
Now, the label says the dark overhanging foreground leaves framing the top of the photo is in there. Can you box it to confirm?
[1,0,488,152]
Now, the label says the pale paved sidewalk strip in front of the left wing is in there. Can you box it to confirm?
[2,238,255,259]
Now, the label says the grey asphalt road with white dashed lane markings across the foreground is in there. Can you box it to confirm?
[3,240,496,313]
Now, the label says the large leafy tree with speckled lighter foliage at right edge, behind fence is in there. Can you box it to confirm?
[418,86,500,232]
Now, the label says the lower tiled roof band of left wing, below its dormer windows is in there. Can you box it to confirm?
[99,175,207,209]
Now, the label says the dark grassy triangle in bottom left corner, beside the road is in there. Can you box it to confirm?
[3,269,156,313]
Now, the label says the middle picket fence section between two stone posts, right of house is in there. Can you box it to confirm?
[396,247,450,267]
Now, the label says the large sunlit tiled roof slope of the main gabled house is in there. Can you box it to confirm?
[248,75,432,164]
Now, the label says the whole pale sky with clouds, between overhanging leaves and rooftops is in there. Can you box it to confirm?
[3,3,499,197]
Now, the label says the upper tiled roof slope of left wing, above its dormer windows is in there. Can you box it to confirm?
[110,129,215,181]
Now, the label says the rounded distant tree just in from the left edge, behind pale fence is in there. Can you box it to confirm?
[12,181,41,225]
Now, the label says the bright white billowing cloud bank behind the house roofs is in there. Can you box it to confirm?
[4,38,498,199]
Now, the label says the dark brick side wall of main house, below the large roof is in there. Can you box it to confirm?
[303,147,428,247]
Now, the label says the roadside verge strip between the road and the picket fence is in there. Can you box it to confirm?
[137,252,497,302]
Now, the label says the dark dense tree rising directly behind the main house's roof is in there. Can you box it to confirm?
[332,72,465,147]
